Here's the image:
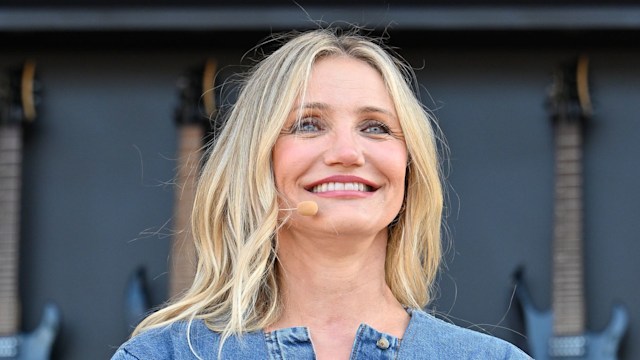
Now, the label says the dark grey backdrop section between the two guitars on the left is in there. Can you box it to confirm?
[22,51,208,359]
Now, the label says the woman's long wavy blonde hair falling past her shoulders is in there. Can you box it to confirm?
[134,29,443,340]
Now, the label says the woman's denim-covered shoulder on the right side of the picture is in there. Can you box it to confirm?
[401,310,531,359]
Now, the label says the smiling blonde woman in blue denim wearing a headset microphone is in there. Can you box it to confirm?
[113,30,528,359]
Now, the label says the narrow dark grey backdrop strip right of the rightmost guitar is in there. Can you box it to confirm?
[584,50,640,359]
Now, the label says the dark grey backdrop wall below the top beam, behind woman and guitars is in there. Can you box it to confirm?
[0,2,640,360]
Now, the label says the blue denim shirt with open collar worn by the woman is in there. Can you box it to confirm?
[111,309,531,360]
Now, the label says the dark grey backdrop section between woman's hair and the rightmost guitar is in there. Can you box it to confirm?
[420,50,554,345]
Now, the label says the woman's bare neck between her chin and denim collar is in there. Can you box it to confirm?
[272,229,408,337]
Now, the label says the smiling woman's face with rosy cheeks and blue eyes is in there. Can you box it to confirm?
[273,56,407,235]
